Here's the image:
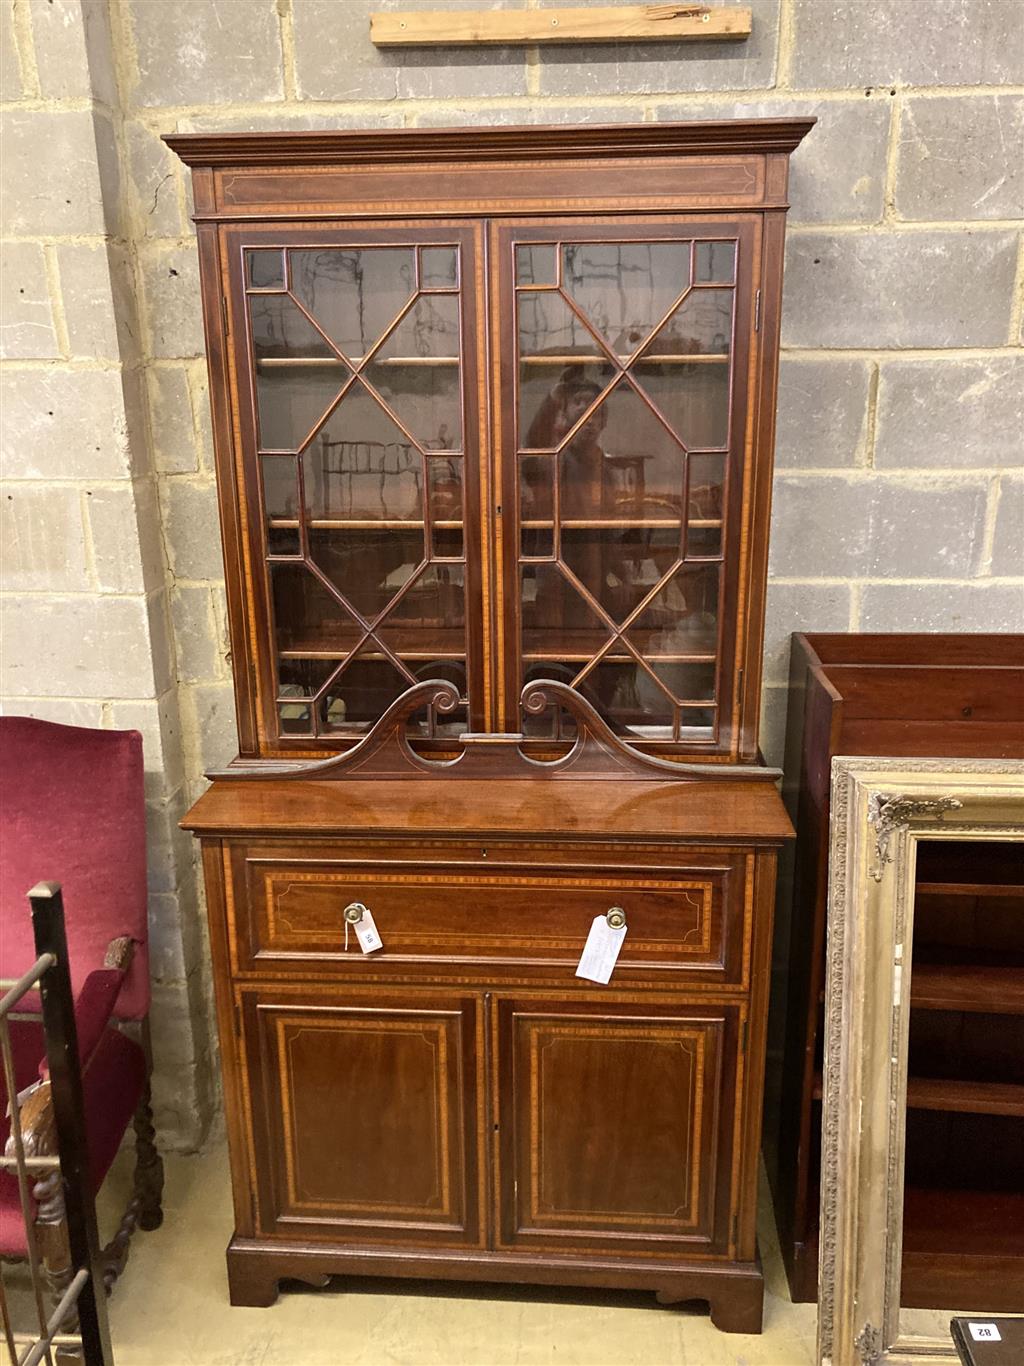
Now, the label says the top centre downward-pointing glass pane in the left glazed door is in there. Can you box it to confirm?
[288,247,416,359]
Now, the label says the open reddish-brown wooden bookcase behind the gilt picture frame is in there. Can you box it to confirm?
[766,635,1024,1311]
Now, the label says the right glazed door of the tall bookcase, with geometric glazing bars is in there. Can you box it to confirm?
[492,216,766,754]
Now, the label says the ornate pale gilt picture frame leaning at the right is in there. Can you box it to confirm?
[816,758,1024,1366]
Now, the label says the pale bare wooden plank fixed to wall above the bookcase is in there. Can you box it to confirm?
[370,4,751,48]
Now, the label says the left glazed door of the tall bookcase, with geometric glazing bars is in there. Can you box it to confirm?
[224,221,487,753]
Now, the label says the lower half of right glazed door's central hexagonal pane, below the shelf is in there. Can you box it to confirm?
[561,527,679,624]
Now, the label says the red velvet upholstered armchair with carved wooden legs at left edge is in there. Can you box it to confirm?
[0,716,164,1298]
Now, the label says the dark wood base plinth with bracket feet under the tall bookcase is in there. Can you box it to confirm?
[227,1238,765,1333]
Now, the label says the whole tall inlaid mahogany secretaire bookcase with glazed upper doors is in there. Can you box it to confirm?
[168,120,810,1330]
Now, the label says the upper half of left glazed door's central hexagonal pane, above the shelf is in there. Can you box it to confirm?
[303,380,423,520]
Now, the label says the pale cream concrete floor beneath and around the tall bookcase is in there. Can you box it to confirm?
[100,1149,815,1366]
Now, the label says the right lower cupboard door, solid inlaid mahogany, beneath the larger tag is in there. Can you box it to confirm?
[496,1000,739,1255]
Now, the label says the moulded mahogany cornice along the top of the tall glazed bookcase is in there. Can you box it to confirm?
[164,119,816,167]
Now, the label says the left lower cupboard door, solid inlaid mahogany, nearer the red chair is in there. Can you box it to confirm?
[243,989,483,1244]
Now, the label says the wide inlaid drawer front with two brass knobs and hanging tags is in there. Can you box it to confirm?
[225,846,752,984]
